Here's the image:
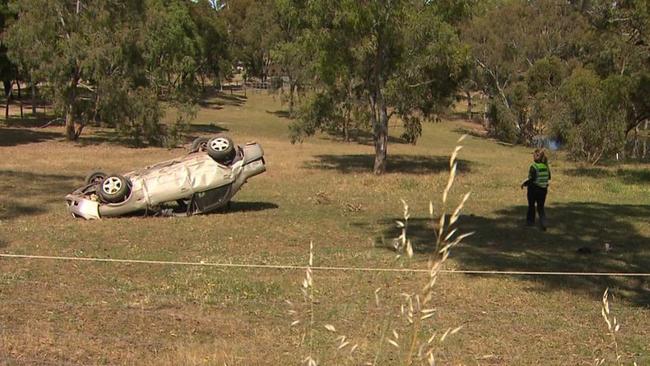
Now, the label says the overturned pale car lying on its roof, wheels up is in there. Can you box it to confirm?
[66,135,266,219]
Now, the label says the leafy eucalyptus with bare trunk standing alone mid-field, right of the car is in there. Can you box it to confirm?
[294,0,468,174]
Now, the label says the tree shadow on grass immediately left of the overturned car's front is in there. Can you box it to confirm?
[0,170,83,220]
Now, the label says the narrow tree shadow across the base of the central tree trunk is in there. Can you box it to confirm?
[305,154,473,174]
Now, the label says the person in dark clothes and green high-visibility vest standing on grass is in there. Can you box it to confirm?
[521,149,551,231]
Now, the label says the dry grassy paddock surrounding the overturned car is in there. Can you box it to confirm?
[0,89,650,365]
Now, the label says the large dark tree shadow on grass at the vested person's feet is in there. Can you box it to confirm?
[372,203,650,306]
